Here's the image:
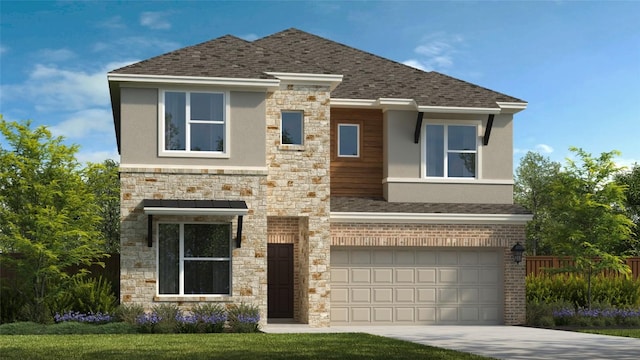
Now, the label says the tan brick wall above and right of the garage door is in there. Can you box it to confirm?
[331,223,526,325]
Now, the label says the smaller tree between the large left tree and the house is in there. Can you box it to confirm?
[85,159,120,253]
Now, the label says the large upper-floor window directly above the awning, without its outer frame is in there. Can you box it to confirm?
[160,91,228,155]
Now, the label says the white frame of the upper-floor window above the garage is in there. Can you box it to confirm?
[420,120,482,182]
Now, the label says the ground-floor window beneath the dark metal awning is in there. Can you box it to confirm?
[158,223,231,295]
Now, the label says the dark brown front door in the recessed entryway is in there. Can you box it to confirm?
[267,244,293,318]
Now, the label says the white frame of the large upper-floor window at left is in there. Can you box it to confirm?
[158,88,231,158]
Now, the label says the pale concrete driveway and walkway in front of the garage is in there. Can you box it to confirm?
[263,324,640,360]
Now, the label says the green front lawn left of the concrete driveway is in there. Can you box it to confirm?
[0,333,487,360]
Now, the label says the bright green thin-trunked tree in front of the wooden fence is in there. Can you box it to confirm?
[546,148,634,306]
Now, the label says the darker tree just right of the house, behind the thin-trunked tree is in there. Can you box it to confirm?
[514,151,560,256]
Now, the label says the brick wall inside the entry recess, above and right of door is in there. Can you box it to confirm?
[267,216,307,322]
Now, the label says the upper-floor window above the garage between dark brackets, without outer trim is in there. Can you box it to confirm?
[425,124,478,178]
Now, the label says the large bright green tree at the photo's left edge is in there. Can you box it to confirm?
[0,116,105,322]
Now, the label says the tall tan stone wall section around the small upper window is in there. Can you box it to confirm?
[266,85,330,327]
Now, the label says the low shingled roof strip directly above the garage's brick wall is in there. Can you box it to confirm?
[331,196,531,215]
